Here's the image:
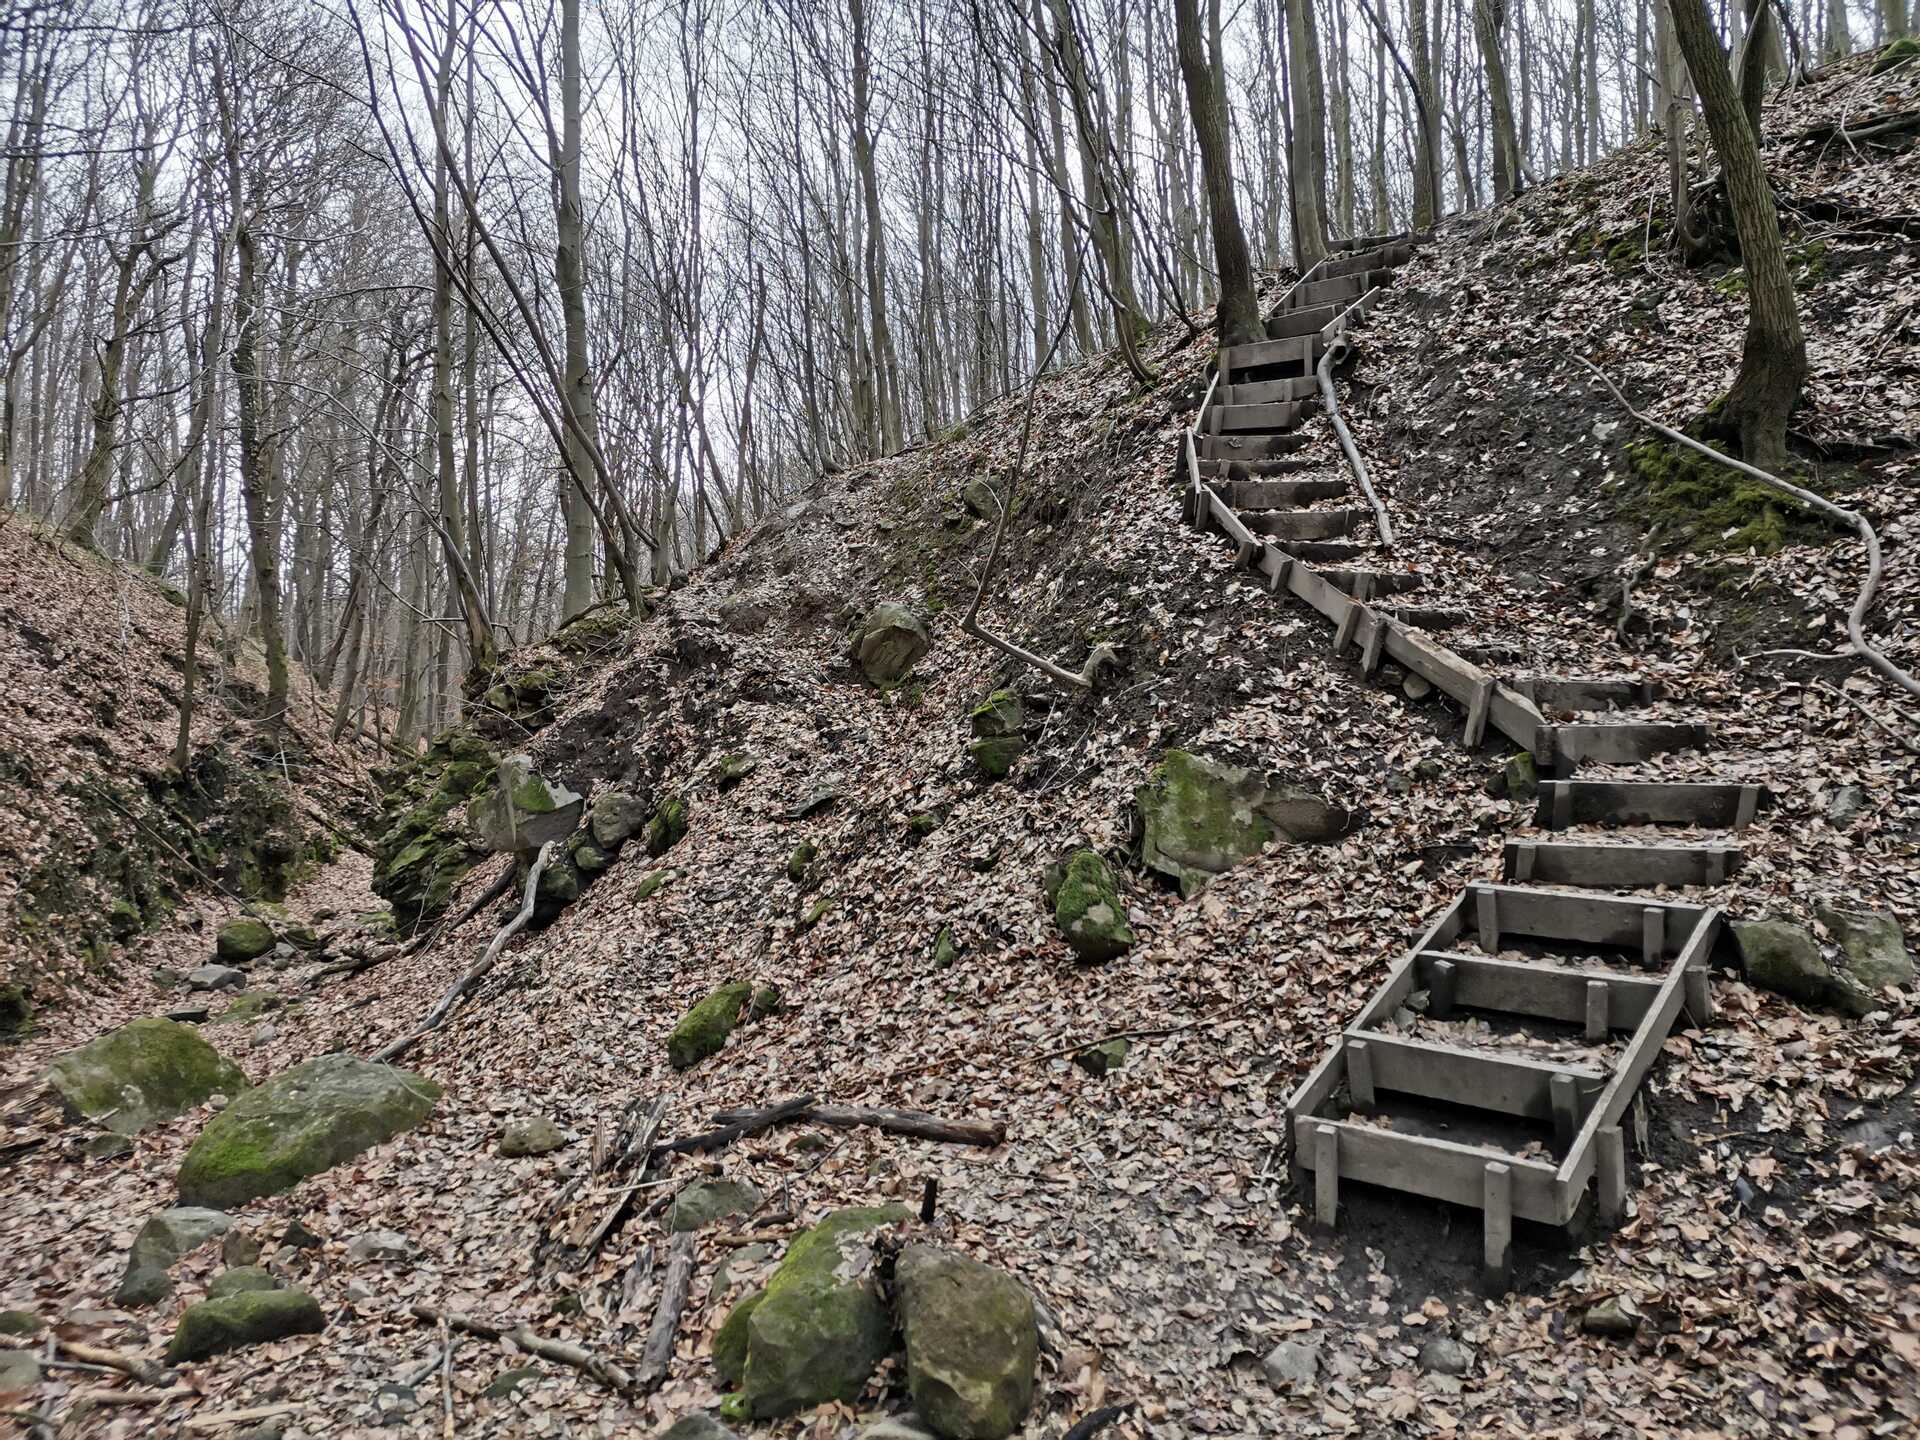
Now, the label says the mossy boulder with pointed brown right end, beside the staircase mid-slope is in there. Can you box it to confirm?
[1133,751,1357,895]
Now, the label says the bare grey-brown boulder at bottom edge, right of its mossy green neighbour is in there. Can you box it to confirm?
[893,1244,1041,1440]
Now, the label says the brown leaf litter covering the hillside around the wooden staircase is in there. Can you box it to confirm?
[0,48,1920,1436]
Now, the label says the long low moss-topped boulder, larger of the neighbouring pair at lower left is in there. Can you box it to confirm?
[179,1054,440,1206]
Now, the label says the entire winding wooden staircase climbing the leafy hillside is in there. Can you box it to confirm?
[1183,236,1768,1292]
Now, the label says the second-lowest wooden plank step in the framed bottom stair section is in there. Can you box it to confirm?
[1344,1029,1607,1140]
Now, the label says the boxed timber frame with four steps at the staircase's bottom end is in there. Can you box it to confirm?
[1286,885,1720,1294]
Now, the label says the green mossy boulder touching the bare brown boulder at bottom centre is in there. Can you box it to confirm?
[728,1206,908,1419]
